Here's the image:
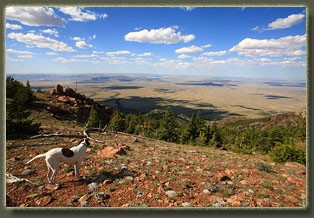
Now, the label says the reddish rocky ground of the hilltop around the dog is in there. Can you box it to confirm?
[6,124,307,207]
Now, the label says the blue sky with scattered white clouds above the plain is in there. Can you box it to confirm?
[6,7,306,80]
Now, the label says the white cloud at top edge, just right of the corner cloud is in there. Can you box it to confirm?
[59,7,108,22]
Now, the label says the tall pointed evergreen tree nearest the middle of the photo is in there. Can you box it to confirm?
[157,107,179,142]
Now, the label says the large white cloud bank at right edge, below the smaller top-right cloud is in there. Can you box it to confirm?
[229,35,306,57]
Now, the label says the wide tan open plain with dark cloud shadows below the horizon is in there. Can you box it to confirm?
[15,74,306,120]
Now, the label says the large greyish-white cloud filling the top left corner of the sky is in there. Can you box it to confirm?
[6,7,65,27]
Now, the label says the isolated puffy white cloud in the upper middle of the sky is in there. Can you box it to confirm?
[124,27,195,44]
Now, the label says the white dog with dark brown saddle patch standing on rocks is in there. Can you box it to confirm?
[26,139,89,184]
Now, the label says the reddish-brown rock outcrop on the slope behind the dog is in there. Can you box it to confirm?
[46,84,112,123]
